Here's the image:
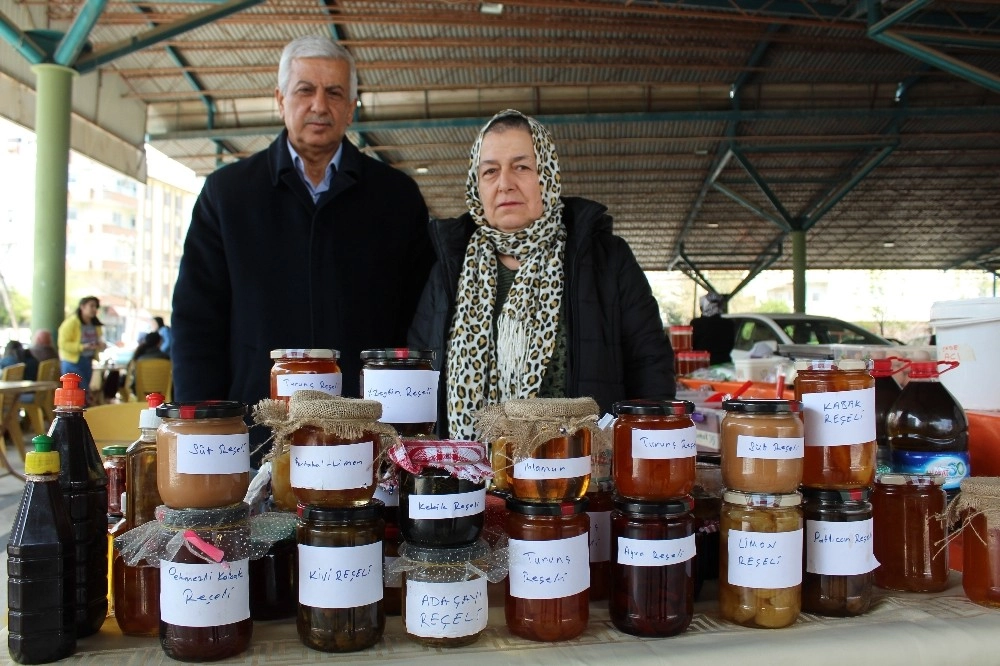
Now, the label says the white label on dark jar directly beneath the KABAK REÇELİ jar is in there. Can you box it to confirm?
[806,518,878,576]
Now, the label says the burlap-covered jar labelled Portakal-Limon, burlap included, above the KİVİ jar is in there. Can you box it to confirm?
[254,391,399,508]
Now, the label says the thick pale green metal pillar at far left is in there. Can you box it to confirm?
[31,63,76,333]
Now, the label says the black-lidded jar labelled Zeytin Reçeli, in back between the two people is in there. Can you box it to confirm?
[361,348,441,437]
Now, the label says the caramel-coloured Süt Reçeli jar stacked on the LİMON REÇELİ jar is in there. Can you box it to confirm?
[720,399,805,493]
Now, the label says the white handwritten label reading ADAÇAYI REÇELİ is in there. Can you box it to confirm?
[406,577,489,638]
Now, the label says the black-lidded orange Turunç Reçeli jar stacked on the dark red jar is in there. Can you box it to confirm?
[613,400,697,502]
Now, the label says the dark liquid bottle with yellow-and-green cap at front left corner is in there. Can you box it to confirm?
[7,435,76,664]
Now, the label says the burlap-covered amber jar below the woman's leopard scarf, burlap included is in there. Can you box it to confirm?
[476,398,603,502]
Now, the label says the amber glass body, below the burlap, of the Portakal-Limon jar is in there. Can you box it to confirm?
[289,426,380,508]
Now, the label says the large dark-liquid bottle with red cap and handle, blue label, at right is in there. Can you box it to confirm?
[886,361,969,499]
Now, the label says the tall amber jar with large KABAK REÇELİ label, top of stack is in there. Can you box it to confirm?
[795,360,878,490]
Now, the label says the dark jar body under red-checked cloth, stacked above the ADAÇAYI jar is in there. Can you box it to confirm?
[398,465,486,548]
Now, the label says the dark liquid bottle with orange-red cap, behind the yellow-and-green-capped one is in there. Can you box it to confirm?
[49,373,108,638]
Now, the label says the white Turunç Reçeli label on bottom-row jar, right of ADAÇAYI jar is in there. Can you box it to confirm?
[508,534,590,599]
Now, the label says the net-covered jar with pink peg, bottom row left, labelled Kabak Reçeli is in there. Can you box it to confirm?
[160,502,253,661]
